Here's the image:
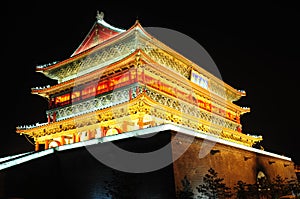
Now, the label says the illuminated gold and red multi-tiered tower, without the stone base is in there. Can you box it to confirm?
[16,10,262,150]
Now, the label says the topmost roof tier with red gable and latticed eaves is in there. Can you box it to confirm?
[36,13,245,101]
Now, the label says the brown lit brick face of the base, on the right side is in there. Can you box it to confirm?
[172,133,296,193]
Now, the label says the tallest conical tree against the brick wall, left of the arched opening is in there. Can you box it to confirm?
[196,168,232,199]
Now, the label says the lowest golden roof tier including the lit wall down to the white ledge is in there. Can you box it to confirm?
[17,91,262,146]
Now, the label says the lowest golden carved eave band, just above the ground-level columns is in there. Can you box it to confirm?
[16,92,262,146]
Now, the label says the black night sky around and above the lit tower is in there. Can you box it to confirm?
[0,0,300,164]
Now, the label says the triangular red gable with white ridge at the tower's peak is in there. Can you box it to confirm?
[71,12,125,57]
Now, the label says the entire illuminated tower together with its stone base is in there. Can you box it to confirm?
[0,13,299,199]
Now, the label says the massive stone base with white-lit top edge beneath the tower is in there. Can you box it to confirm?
[0,125,296,199]
